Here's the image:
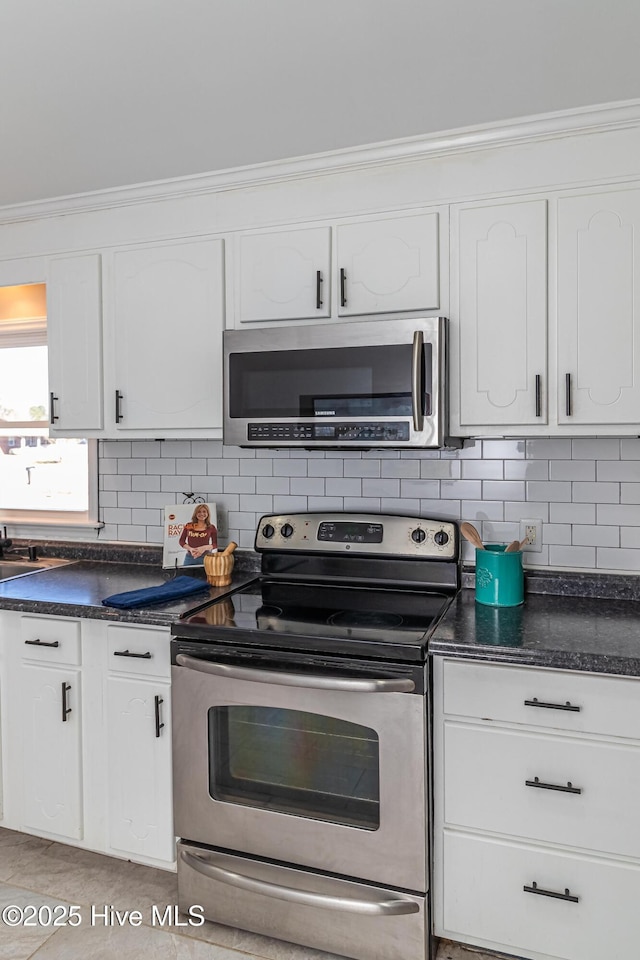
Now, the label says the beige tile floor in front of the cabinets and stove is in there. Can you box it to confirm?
[0,828,500,960]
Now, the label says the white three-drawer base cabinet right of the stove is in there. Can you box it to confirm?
[433,658,640,960]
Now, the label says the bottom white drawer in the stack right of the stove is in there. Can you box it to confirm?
[437,831,640,960]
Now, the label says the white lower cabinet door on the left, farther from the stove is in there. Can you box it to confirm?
[18,664,82,840]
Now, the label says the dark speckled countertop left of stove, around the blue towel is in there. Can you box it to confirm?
[0,560,256,625]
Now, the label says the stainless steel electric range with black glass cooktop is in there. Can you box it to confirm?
[171,514,460,960]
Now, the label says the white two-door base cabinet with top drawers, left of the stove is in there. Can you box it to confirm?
[0,612,175,869]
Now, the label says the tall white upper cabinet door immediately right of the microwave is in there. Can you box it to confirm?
[452,200,548,430]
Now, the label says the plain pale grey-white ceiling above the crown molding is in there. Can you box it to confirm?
[0,0,640,206]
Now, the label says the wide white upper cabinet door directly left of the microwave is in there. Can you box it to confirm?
[112,240,224,436]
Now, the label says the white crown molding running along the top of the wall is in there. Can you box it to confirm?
[0,99,640,224]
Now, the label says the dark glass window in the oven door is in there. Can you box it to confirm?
[209,706,380,830]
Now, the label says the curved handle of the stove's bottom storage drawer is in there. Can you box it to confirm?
[180,850,420,917]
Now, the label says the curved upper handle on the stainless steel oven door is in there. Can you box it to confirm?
[176,653,416,693]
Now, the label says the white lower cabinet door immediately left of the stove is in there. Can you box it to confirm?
[106,677,175,862]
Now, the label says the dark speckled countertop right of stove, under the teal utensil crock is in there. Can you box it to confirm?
[429,590,640,677]
